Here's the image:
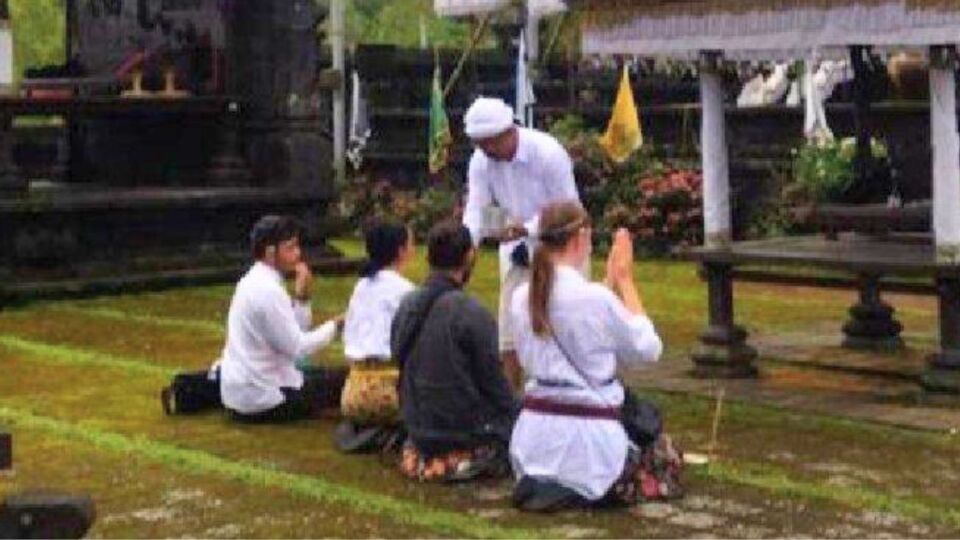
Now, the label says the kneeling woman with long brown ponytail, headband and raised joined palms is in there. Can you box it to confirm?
[510,202,662,510]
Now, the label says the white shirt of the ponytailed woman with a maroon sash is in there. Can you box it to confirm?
[510,265,663,500]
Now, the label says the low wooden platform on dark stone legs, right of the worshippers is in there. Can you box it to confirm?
[680,234,960,391]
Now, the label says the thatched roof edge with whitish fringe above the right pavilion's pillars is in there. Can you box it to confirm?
[568,0,960,58]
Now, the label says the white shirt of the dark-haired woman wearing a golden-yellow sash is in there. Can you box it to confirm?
[343,269,416,360]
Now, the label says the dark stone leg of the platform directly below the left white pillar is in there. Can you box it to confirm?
[693,263,757,378]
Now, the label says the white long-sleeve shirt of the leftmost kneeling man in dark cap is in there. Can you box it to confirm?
[220,262,337,414]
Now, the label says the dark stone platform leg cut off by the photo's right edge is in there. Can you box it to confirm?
[921,275,960,395]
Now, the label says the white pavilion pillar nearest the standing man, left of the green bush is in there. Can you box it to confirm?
[700,55,733,248]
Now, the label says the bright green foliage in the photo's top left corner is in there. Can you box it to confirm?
[10,0,66,80]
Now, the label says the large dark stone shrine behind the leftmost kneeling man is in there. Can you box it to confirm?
[0,0,334,292]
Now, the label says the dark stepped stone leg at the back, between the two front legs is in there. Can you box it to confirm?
[843,274,903,350]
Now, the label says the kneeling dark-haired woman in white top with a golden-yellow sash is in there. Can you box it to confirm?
[340,222,416,426]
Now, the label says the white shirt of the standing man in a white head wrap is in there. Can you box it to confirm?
[463,128,580,274]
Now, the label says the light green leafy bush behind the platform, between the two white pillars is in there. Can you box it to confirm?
[793,137,887,203]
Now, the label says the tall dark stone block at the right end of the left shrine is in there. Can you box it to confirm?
[227,0,333,194]
